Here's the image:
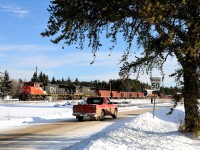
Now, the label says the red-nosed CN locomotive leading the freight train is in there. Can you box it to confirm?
[19,82,76,100]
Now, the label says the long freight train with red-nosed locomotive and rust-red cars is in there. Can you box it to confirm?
[19,82,144,100]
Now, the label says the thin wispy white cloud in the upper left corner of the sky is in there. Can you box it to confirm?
[0,3,30,17]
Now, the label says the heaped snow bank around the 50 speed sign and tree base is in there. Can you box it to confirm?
[85,107,200,150]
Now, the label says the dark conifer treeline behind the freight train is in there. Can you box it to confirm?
[31,72,181,95]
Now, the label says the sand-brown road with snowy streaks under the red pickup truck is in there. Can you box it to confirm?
[0,108,155,150]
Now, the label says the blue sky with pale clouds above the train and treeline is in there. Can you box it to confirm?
[0,0,178,86]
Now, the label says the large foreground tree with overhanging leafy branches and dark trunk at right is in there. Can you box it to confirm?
[42,0,200,135]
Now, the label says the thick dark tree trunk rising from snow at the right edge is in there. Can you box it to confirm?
[183,63,200,136]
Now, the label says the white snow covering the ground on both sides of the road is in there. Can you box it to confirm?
[0,100,200,150]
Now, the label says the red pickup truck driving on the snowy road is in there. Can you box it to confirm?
[72,97,118,121]
